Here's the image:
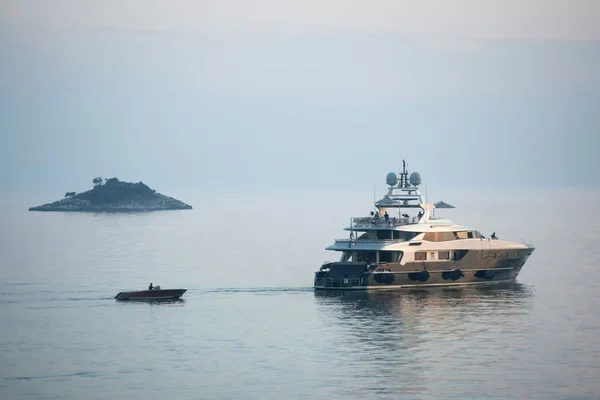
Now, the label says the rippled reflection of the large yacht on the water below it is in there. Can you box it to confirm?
[314,283,533,398]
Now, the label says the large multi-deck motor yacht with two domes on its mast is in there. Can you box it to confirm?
[314,161,535,290]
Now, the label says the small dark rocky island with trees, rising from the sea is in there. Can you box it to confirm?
[29,178,192,212]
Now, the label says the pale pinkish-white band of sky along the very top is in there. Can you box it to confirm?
[0,0,600,39]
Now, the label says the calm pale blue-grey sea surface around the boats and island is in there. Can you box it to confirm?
[0,188,600,400]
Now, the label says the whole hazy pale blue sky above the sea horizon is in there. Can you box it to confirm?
[0,0,600,192]
